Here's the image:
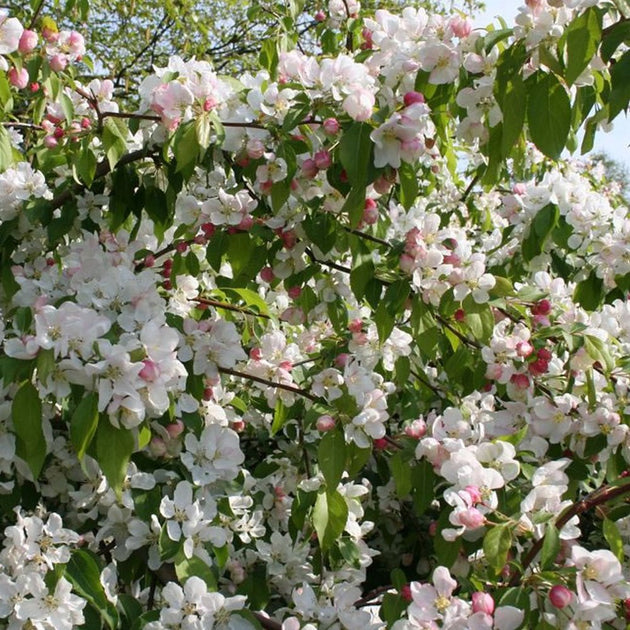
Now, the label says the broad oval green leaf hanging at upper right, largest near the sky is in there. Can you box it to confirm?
[526,70,571,160]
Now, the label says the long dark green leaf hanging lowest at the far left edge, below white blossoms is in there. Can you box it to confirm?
[11,381,47,479]
